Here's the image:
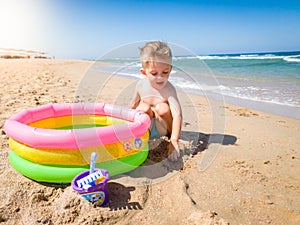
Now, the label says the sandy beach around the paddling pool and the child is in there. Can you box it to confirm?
[0,59,300,224]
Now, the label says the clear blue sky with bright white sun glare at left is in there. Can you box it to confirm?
[0,0,300,59]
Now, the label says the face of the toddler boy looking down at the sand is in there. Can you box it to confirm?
[141,61,172,90]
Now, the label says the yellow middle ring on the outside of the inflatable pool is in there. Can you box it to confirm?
[8,132,149,165]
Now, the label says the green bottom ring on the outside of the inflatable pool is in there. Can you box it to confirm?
[9,144,148,183]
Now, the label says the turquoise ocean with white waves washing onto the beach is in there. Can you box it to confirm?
[96,51,300,119]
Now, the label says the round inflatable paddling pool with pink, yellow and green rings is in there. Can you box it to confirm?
[4,103,150,183]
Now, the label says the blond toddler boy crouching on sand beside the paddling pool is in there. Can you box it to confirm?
[132,41,182,161]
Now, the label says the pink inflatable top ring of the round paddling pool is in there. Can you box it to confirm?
[4,103,150,149]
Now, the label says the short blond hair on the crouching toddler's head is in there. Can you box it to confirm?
[140,41,172,67]
